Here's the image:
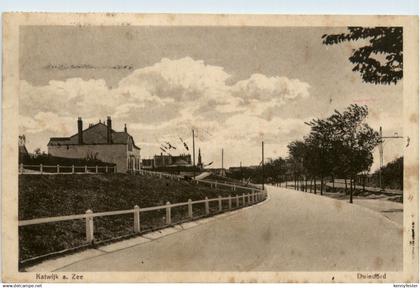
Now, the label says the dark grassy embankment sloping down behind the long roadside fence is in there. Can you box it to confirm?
[19,174,253,261]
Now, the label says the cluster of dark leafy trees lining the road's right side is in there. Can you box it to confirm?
[288,104,381,203]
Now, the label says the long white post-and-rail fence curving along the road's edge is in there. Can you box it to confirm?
[19,187,267,243]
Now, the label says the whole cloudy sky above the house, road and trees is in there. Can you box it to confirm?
[19,26,405,168]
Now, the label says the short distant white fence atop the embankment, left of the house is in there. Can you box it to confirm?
[19,164,117,174]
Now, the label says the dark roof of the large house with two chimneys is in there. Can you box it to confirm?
[48,123,140,149]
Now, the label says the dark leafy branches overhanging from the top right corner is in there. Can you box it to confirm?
[322,27,403,84]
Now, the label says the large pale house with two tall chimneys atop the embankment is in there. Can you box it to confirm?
[47,116,140,173]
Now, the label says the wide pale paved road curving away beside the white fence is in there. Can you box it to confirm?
[57,187,403,271]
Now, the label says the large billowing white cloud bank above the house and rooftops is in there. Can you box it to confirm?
[20,57,309,165]
